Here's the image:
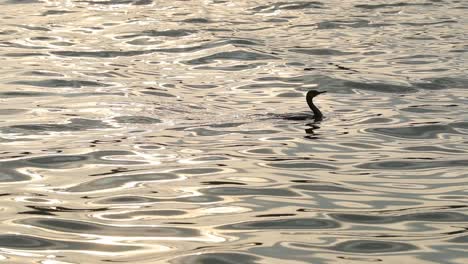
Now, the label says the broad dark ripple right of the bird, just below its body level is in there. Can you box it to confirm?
[365,125,460,139]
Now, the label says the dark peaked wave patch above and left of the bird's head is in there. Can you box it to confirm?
[184,50,278,65]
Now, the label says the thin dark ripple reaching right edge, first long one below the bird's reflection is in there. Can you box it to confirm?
[356,160,468,170]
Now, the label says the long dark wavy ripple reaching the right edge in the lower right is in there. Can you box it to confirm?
[329,212,468,225]
